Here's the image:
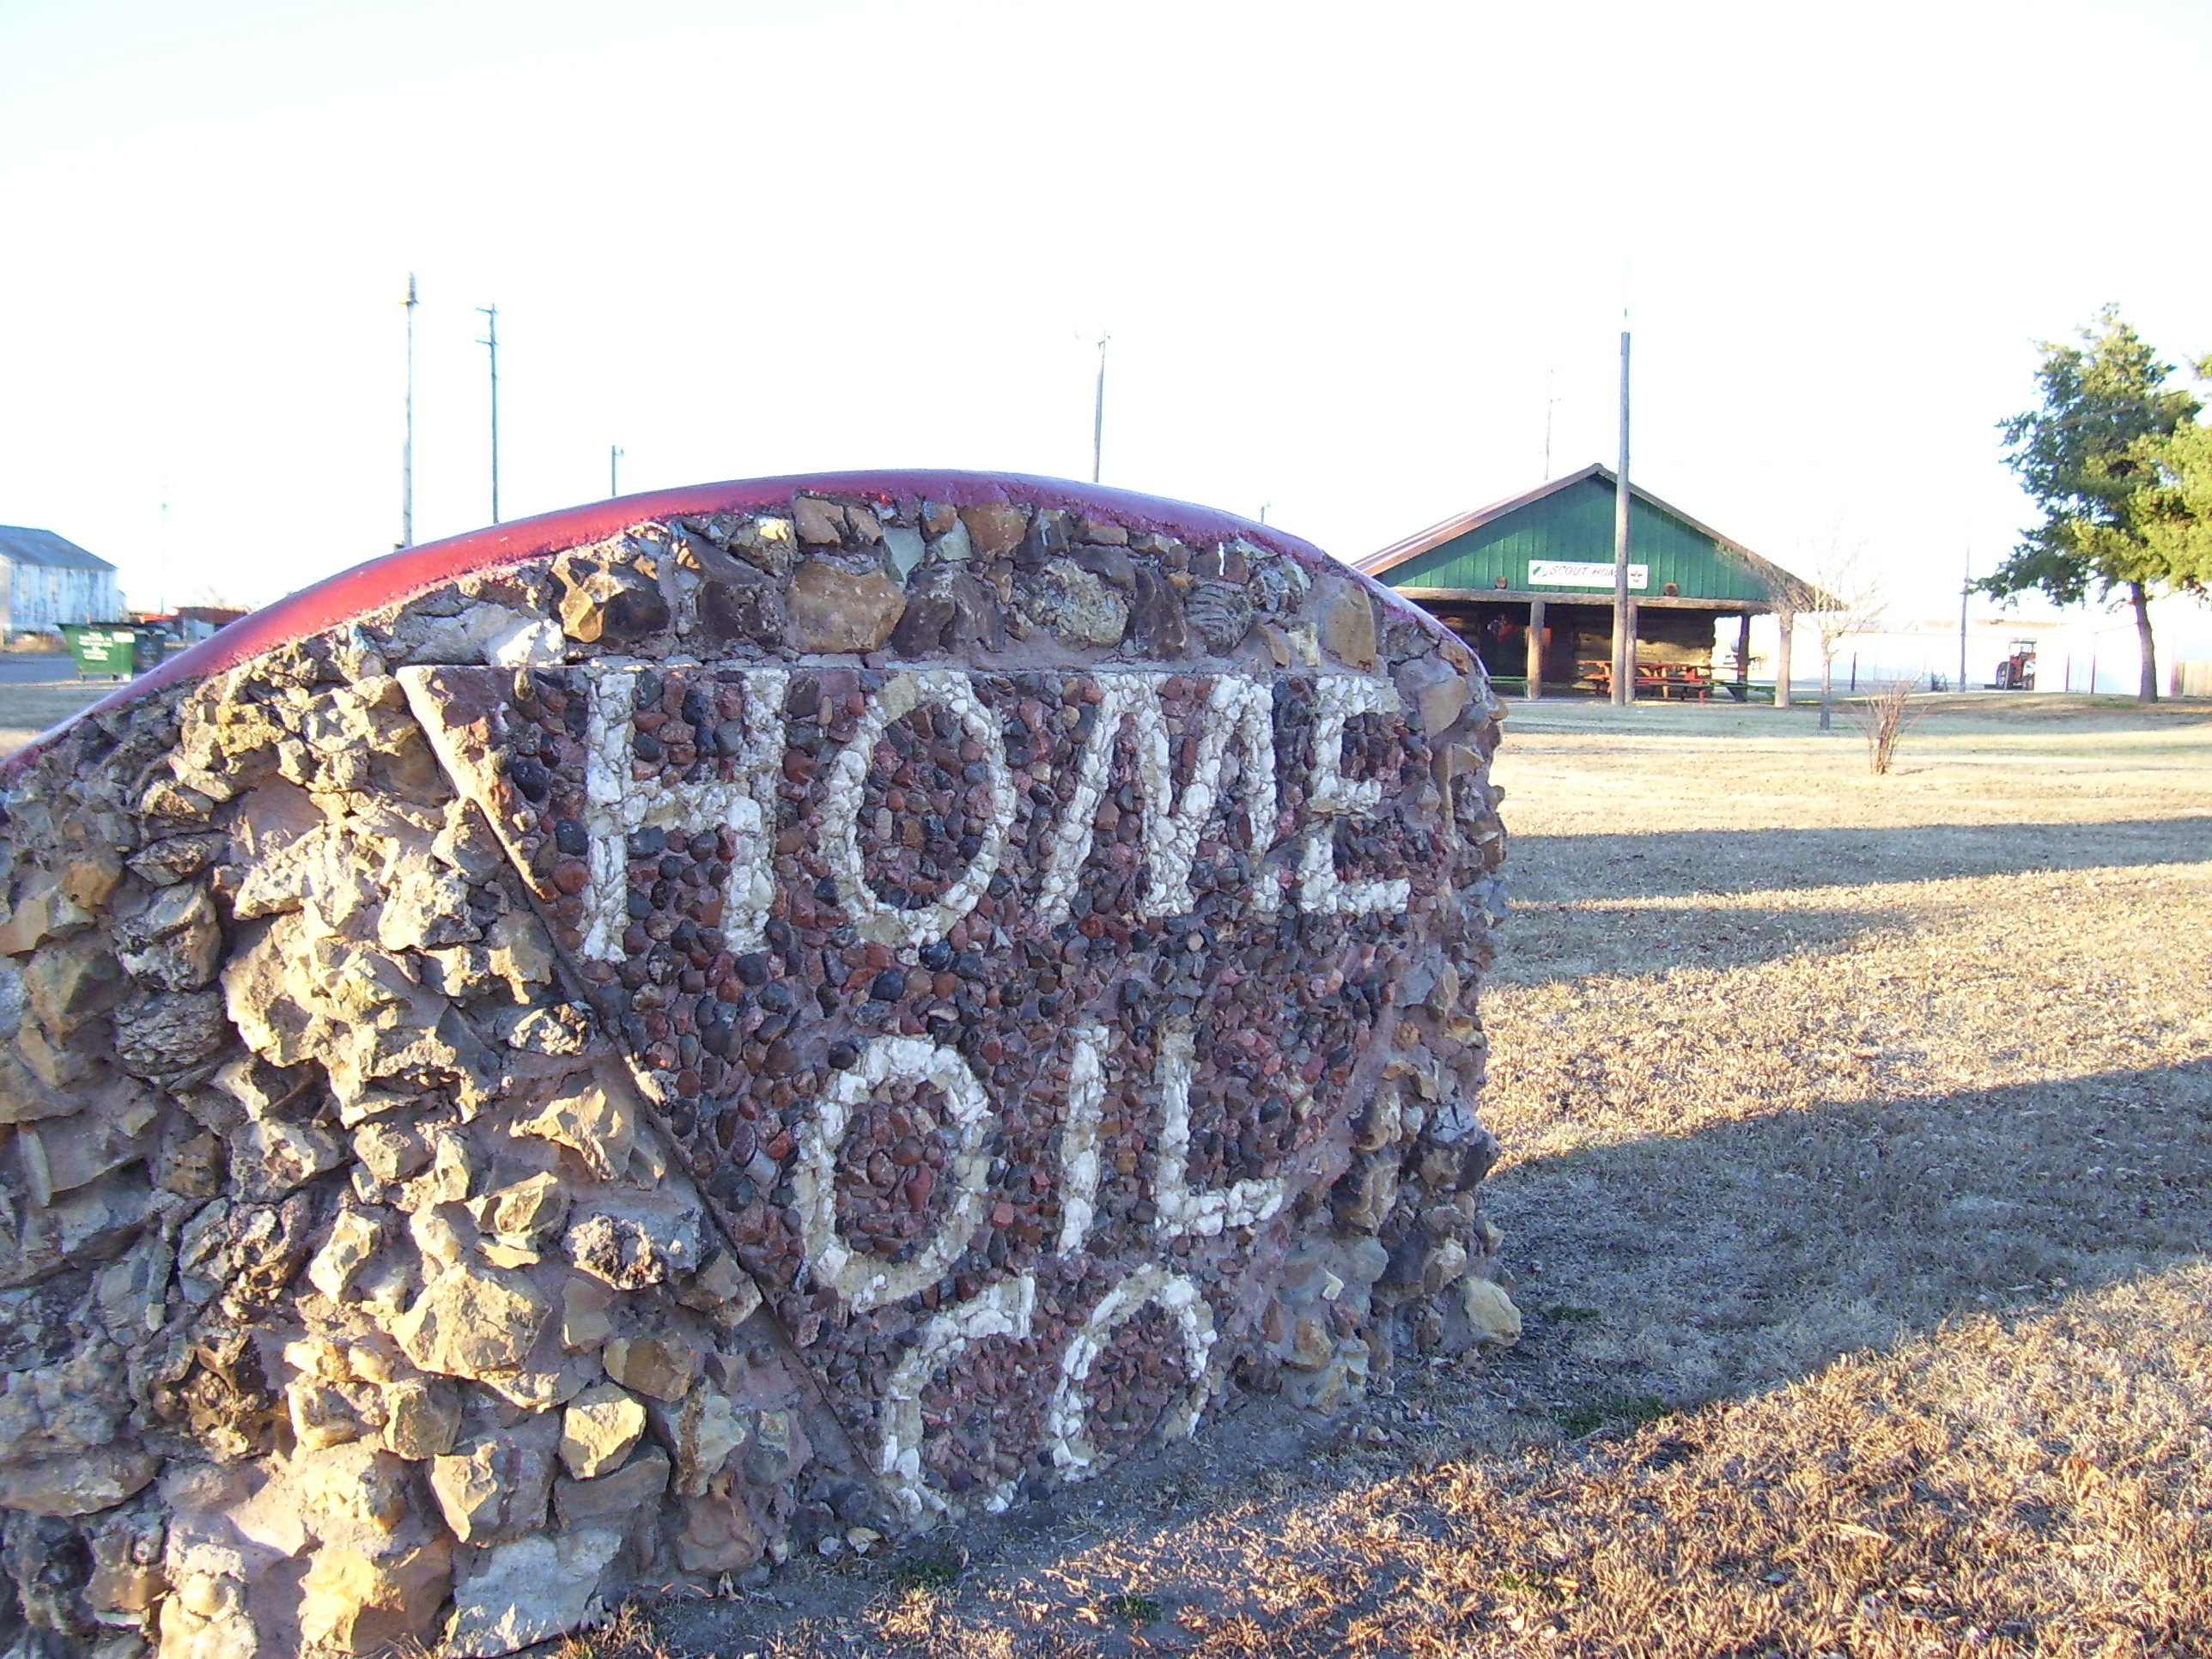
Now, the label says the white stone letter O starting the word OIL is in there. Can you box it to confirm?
[792,1037,995,1312]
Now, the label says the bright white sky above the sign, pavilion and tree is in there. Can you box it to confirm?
[0,0,2212,663]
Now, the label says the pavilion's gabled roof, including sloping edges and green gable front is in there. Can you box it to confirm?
[1358,465,1805,608]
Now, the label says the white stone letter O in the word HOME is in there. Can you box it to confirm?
[821,668,1013,949]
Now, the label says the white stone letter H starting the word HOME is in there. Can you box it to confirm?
[584,664,790,960]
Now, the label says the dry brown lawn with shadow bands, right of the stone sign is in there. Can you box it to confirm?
[17,692,2212,1659]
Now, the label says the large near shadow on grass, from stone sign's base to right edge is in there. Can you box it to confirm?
[632,1061,2212,1659]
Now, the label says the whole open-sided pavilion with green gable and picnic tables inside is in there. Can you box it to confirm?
[1358,465,1818,706]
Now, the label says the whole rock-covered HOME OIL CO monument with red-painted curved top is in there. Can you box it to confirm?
[0,473,1516,1659]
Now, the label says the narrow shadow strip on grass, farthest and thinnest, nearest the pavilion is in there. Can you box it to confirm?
[1506,817,2212,902]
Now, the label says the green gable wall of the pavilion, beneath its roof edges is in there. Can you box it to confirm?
[1382,477,1767,599]
